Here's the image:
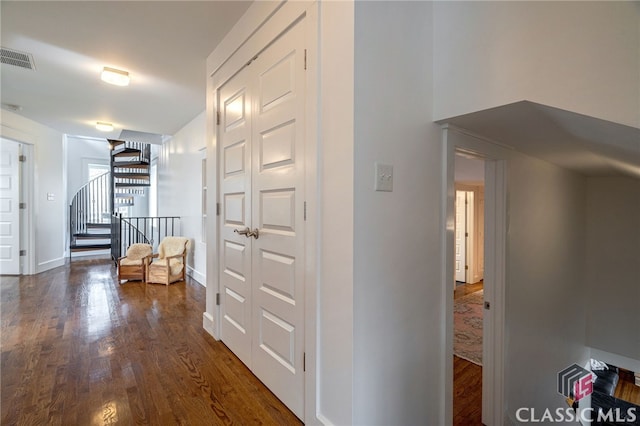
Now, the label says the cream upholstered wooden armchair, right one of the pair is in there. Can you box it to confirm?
[147,237,191,285]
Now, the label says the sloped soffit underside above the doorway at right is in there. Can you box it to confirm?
[440,101,640,179]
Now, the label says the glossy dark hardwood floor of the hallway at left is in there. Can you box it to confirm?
[0,259,301,425]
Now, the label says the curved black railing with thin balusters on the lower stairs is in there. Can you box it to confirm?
[69,172,111,251]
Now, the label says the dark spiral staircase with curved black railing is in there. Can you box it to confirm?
[69,139,151,257]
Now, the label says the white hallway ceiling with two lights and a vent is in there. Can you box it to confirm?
[0,0,251,138]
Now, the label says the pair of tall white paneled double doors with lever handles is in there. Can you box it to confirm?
[218,23,305,418]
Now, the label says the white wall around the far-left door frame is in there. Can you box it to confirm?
[1,110,68,273]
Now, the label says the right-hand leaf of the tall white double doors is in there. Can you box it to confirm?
[252,20,305,418]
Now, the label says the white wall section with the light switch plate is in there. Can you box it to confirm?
[353,2,445,425]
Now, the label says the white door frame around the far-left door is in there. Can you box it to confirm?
[0,131,37,275]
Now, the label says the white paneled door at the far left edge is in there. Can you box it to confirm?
[0,139,20,275]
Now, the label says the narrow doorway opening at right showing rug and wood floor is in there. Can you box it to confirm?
[453,152,485,425]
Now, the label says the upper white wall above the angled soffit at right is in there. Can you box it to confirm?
[434,1,640,127]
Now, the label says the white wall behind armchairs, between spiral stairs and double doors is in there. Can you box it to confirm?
[158,111,207,285]
